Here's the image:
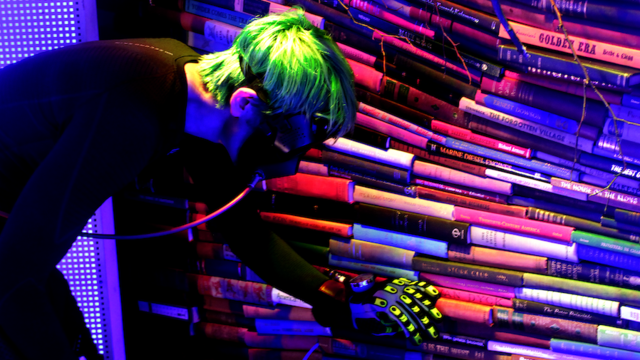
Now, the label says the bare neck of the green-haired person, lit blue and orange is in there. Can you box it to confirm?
[184,63,251,162]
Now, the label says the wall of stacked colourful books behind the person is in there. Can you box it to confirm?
[144,0,640,359]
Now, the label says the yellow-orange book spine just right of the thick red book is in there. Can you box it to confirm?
[353,186,453,220]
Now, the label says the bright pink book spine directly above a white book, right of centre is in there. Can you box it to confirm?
[453,206,575,243]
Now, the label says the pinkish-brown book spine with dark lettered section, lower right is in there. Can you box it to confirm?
[493,306,598,344]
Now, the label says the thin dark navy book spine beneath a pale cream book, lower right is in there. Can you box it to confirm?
[513,298,621,326]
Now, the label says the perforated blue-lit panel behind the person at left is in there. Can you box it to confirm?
[0,0,125,360]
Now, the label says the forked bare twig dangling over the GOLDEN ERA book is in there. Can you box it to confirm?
[550,0,637,200]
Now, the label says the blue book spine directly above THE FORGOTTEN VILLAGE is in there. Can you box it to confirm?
[476,94,578,134]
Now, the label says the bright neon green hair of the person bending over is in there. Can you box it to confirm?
[199,7,356,137]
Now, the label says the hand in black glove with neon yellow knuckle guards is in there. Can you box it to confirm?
[348,278,442,345]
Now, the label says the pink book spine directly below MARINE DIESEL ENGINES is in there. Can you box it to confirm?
[413,161,511,195]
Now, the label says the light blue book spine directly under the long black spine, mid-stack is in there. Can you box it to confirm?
[353,224,449,259]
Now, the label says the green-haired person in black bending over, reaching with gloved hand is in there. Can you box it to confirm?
[0,9,440,359]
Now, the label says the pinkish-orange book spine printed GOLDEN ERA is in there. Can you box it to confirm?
[499,22,640,69]
